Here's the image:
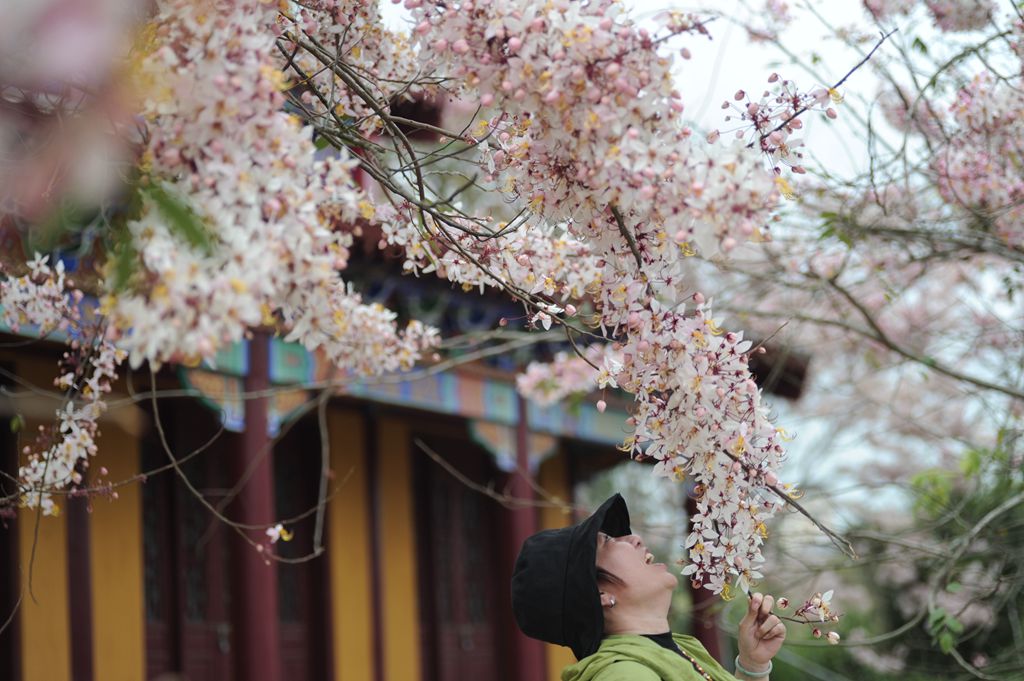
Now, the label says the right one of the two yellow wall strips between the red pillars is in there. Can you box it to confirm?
[374,418,421,681]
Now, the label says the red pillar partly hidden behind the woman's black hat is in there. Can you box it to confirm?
[509,395,548,681]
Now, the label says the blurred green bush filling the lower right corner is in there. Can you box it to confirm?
[772,436,1024,681]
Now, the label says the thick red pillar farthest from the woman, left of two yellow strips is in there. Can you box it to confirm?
[231,332,282,681]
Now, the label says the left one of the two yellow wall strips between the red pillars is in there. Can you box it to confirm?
[327,409,374,681]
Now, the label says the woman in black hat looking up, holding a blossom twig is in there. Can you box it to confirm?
[512,494,785,681]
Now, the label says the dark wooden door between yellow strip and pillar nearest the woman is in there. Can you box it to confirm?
[417,436,509,681]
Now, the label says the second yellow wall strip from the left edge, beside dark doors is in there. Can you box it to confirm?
[89,423,145,681]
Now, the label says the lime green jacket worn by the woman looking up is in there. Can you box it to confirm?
[562,634,735,681]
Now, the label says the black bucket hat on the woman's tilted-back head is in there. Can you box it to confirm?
[512,494,631,659]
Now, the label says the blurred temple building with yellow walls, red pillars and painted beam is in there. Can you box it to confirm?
[0,245,643,681]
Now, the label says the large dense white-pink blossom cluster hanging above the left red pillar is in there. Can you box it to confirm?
[104,0,435,374]
